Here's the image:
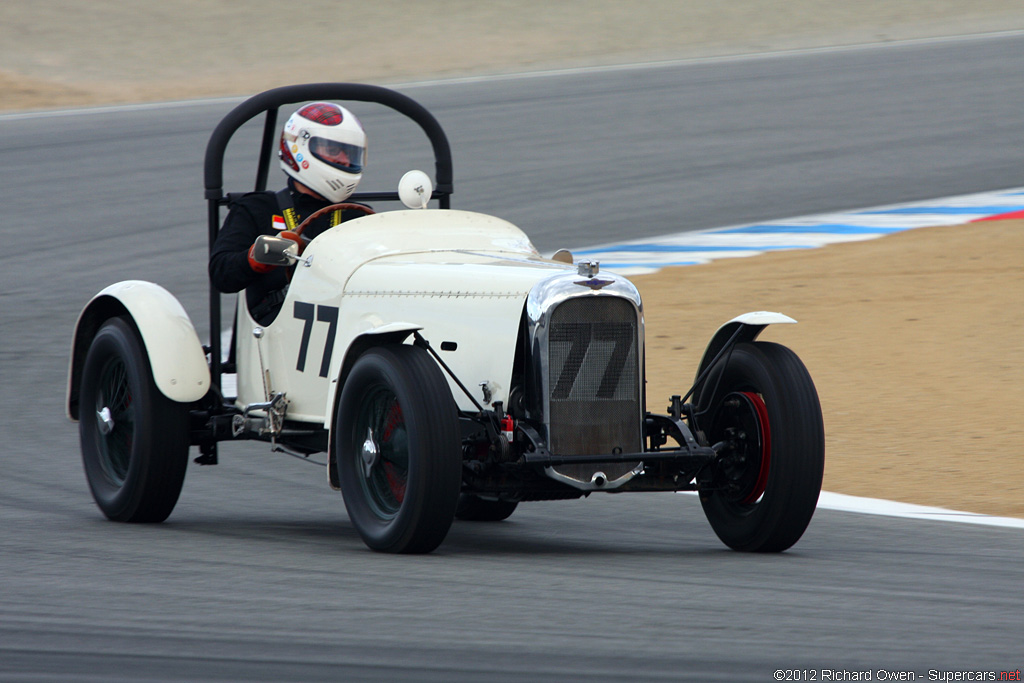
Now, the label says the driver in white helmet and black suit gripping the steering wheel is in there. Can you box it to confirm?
[209,102,367,325]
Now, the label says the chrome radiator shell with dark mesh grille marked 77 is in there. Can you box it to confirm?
[525,272,644,487]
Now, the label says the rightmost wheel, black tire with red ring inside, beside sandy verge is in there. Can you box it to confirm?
[697,342,824,552]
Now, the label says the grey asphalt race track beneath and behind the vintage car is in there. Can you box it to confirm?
[0,30,1024,681]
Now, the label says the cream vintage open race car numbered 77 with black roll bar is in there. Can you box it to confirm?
[68,83,824,552]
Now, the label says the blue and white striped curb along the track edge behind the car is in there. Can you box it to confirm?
[572,187,1024,275]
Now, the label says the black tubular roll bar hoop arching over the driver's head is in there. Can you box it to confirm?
[203,83,454,390]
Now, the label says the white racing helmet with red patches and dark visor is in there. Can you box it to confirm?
[278,102,367,203]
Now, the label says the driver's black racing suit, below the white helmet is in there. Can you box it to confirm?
[209,180,359,325]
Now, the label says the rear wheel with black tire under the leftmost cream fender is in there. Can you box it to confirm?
[79,317,188,522]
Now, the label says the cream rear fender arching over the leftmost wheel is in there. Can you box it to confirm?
[67,280,210,420]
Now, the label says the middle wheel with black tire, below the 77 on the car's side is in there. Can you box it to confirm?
[335,344,462,553]
